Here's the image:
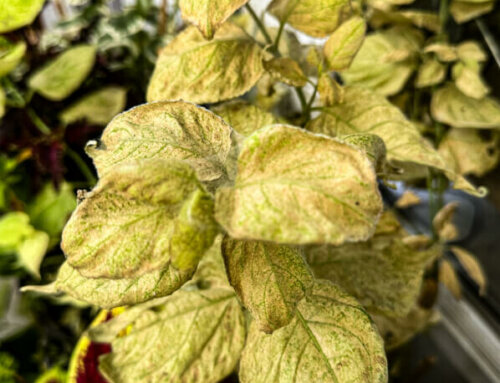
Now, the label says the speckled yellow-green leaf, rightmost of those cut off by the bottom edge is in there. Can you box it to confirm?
[239,281,388,383]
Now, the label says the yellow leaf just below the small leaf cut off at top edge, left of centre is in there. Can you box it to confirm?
[147,24,264,104]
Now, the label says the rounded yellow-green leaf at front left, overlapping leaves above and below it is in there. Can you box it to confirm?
[61,159,215,278]
